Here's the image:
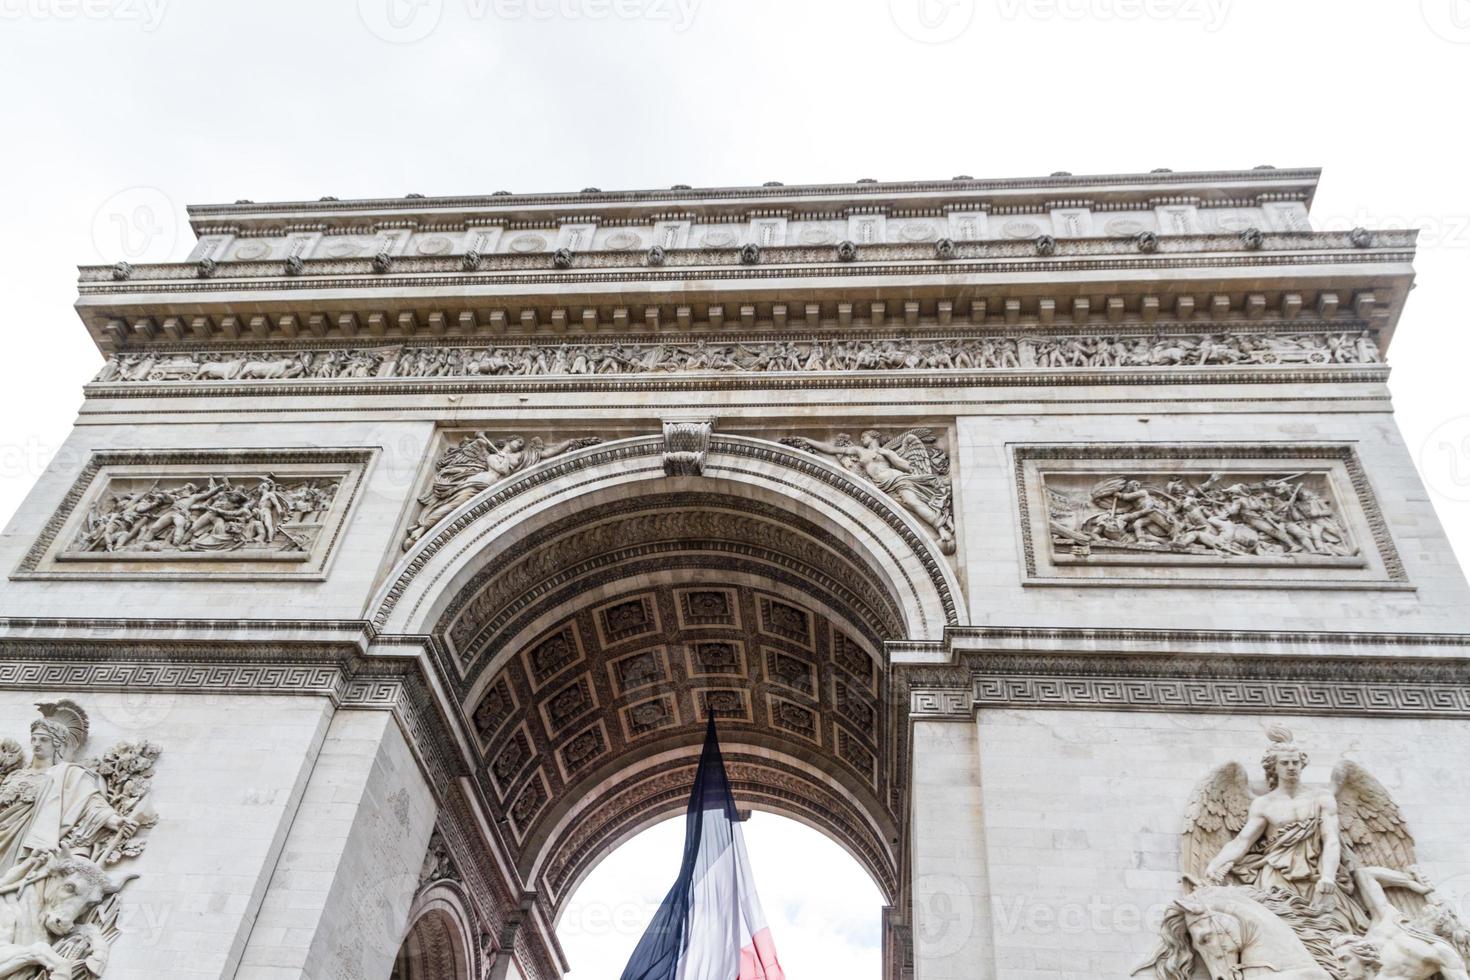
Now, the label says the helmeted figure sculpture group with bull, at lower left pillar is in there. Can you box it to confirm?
[0,701,159,980]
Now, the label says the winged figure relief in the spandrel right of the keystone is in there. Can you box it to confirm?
[782,428,954,554]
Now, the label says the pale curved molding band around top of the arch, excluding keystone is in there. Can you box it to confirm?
[373,435,963,639]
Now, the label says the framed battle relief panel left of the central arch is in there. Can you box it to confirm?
[13,450,373,579]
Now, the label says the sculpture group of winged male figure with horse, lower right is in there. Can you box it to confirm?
[1135,727,1470,980]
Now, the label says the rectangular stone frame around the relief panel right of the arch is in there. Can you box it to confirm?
[1013,442,1408,588]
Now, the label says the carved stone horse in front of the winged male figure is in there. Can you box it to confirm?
[1135,886,1335,980]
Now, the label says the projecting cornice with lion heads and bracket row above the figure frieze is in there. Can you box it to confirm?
[76,232,1414,353]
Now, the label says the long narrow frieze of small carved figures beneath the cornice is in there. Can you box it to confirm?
[93,331,1382,385]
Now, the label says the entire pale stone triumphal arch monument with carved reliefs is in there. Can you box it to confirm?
[0,167,1470,980]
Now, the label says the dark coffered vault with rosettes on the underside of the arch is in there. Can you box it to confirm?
[429,489,904,921]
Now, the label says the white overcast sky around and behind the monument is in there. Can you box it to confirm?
[0,0,1470,980]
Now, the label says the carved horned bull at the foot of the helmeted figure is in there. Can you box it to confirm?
[0,854,137,980]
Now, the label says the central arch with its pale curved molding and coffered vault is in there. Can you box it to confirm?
[375,436,963,946]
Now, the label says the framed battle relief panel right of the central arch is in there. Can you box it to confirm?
[1014,444,1408,588]
